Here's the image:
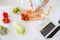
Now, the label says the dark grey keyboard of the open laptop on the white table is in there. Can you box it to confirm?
[40,22,55,36]
